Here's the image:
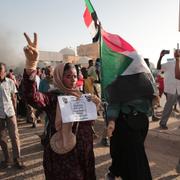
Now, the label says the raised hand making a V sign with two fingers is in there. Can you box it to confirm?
[24,33,39,69]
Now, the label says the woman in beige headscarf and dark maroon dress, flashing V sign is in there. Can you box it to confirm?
[23,33,100,180]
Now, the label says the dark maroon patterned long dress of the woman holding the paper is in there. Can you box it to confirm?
[23,71,96,180]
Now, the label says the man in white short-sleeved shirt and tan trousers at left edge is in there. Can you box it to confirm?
[0,62,25,169]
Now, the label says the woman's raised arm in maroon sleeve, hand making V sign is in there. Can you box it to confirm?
[23,33,49,109]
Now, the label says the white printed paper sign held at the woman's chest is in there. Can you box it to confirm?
[58,94,97,123]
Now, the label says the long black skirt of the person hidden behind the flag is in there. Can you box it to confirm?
[109,113,152,180]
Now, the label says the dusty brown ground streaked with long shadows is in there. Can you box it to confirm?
[0,107,180,180]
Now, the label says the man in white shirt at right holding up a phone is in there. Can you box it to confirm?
[157,50,180,129]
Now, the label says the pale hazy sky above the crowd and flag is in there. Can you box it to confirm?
[0,0,180,67]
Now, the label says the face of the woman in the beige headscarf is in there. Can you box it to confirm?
[63,68,77,89]
